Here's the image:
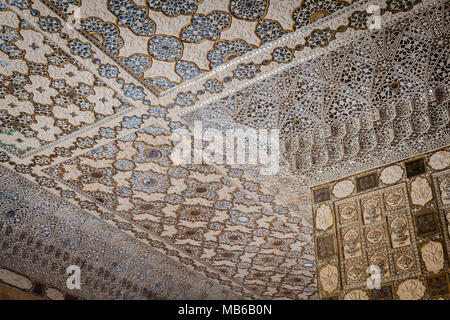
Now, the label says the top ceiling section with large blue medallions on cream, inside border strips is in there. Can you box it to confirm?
[38,0,360,94]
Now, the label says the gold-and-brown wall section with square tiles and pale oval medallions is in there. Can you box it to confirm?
[311,147,450,300]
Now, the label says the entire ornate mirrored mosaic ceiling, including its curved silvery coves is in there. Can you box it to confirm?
[0,0,450,299]
